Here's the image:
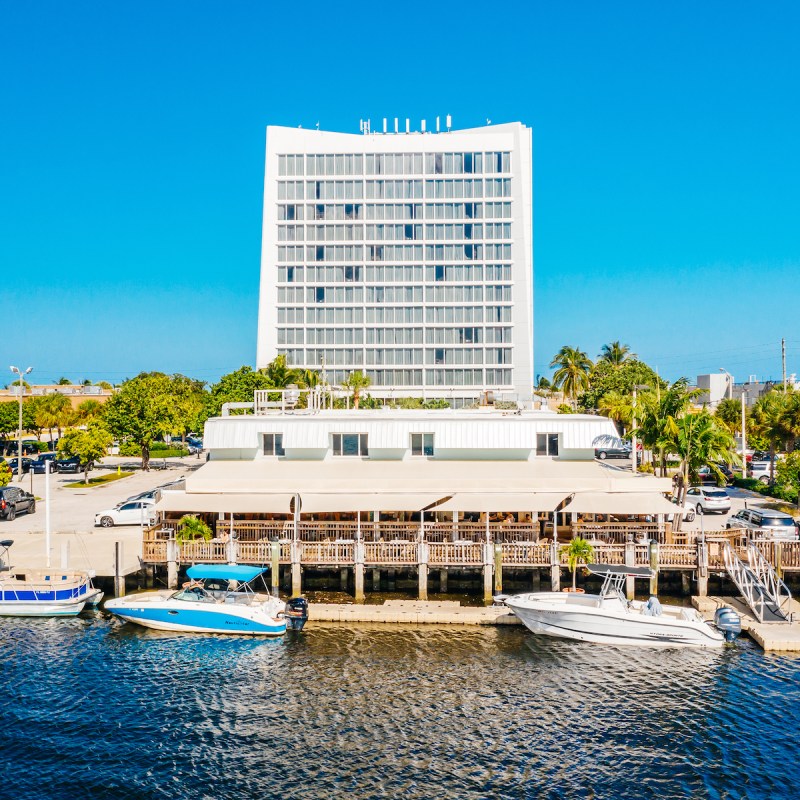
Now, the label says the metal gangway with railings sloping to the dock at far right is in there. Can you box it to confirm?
[723,544,792,622]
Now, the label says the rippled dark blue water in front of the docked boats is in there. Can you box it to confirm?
[0,613,800,800]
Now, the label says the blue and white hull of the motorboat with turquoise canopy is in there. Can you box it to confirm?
[105,594,286,636]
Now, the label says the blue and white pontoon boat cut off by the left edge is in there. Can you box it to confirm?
[0,539,103,617]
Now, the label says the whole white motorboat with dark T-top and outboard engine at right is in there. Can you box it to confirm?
[500,564,741,647]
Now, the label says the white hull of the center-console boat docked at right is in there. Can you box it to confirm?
[505,592,725,647]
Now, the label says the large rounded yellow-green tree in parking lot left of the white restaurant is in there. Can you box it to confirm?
[105,372,180,470]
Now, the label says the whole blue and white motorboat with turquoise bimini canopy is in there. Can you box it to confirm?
[105,564,307,636]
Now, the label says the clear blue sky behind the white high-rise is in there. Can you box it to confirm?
[0,0,800,384]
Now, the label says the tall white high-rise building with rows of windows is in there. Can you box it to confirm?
[257,120,533,402]
